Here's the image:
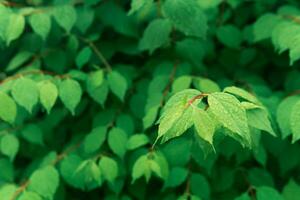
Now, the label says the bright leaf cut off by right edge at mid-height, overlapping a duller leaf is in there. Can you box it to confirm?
[290,101,300,142]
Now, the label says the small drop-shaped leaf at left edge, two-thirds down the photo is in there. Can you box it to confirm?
[0,134,20,161]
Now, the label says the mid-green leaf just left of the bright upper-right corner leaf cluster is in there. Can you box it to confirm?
[253,13,280,41]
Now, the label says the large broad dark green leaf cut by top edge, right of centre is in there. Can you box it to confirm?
[163,0,207,38]
